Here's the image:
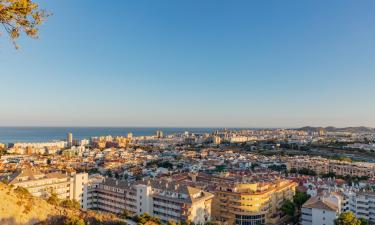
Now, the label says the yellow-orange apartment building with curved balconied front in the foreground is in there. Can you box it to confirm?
[213,180,297,225]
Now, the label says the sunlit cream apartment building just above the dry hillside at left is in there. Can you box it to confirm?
[9,168,88,209]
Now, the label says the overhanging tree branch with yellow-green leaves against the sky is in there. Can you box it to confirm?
[0,0,49,48]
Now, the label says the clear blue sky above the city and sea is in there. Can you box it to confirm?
[0,0,375,127]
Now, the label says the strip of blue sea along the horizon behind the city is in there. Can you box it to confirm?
[0,127,220,144]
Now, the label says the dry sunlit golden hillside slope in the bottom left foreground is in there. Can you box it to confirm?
[0,183,125,225]
